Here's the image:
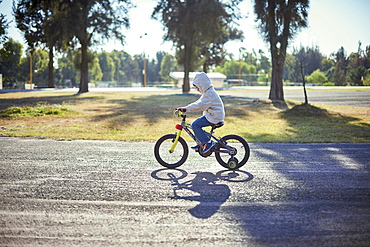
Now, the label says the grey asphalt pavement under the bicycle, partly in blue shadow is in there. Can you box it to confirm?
[0,137,370,247]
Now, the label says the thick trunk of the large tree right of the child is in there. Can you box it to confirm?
[269,51,285,101]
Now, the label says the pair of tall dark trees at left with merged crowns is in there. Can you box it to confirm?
[13,0,132,93]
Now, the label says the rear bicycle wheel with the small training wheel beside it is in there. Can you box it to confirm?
[215,135,250,170]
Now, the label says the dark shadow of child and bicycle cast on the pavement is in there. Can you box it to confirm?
[151,169,253,219]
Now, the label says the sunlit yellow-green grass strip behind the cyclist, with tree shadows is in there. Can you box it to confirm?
[0,90,370,142]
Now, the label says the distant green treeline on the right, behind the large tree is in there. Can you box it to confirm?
[215,42,370,86]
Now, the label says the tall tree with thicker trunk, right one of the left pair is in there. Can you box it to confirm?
[65,0,131,93]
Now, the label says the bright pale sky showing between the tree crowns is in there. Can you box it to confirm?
[0,0,370,58]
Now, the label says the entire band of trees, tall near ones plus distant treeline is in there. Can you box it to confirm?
[0,0,368,100]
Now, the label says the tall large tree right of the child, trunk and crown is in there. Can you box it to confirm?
[254,0,309,100]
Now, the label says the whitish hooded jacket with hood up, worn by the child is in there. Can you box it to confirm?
[185,72,225,124]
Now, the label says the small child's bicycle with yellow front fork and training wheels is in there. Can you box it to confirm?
[154,110,250,170]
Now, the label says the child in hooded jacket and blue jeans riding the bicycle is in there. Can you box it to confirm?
[177,72,225,153]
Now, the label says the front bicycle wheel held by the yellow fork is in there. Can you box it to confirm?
[154,134,189,168]
